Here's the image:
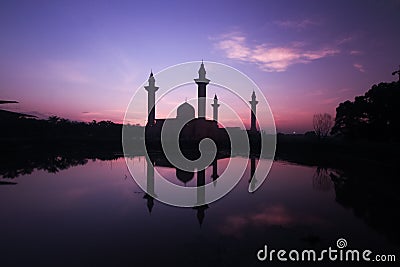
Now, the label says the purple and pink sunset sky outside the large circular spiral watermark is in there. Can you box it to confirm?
[0,0,400,133]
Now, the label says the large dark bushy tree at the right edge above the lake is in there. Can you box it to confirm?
[331,82,400,140]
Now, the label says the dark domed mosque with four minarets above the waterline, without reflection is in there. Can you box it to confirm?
[144,62,259,152]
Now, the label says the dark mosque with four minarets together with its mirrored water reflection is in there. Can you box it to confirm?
[143,62,260,226]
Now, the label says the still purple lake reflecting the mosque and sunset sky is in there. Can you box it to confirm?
[0,156,399,266]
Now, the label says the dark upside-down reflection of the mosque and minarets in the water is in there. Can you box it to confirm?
[143,155,257,226]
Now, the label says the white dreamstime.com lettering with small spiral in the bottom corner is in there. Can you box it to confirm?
[257,238,396,262]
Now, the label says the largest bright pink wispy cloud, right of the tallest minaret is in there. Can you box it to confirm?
[214,33,339,72]
